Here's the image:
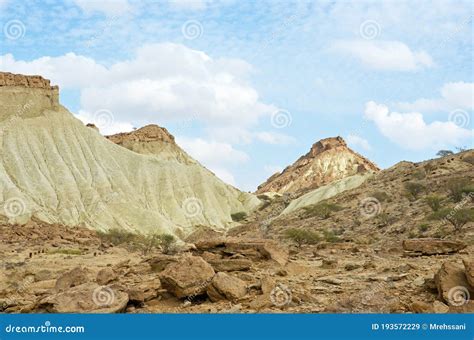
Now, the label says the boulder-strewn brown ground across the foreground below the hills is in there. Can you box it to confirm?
[0,218,474,313]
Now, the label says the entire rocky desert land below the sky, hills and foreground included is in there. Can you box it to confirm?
[0,74,474,313]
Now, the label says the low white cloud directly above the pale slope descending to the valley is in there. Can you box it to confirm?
[176,136,249,185]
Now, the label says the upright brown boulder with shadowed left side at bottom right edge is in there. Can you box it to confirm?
[435,262,474,307]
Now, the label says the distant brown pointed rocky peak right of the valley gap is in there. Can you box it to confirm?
[257,137,379,194]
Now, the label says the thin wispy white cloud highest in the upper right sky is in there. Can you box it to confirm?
[333,40,434,71]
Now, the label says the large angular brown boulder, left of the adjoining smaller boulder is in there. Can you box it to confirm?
[160,256,215,298]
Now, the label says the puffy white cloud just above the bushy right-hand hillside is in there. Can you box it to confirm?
[365,101,473,150]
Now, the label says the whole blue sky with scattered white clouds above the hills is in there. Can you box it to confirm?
[0,0,474,191]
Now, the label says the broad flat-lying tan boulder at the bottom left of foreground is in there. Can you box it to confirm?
[34,282,129,313]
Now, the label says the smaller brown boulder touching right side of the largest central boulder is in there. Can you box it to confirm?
[207,272,247,302]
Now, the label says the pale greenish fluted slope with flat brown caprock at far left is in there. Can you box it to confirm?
[0,73,259,236]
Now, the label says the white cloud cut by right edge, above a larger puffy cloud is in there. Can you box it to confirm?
[396,81,474,112]
